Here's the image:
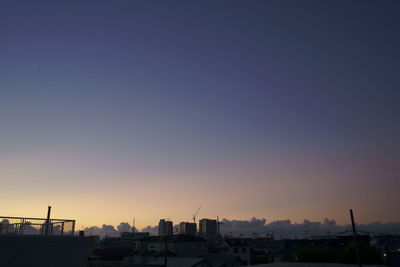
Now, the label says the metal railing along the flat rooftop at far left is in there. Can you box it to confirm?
[0,216,75,236]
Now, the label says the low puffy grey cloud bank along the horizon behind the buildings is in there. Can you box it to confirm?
[84,217,400,238]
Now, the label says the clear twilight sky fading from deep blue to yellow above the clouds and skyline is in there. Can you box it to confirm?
[0,0,400,228]
